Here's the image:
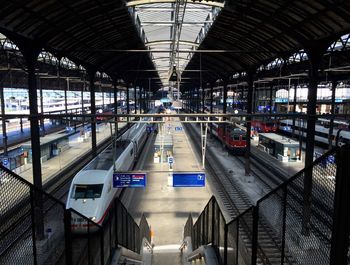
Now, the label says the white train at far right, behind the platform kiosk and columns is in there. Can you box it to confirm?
[279,120,350,148]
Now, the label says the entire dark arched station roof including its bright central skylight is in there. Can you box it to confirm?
[0,0,350,89]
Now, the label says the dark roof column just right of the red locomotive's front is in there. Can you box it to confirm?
[244,70,255,176]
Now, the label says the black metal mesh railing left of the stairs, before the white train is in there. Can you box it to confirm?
[0,166,150,265]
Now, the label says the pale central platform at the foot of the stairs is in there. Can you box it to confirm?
[128,116,212,265]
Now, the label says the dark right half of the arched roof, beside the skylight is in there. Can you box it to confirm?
[183,0,350,84]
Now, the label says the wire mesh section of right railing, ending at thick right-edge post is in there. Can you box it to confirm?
[258,148,336,264]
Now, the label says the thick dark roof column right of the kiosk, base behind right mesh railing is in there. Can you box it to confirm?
[301,45,328,236]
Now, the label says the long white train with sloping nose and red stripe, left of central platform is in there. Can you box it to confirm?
[66,115,152,233]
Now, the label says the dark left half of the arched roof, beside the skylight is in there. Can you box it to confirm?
[0,0,158,88]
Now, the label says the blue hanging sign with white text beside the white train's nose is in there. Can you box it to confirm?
[113,173,147,188]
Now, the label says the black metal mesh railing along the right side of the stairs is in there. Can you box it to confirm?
[184,146,350,265]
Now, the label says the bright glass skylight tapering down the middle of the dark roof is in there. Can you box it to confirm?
[127,0,224,86]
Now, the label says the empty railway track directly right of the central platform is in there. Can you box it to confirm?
[185,121,296,265]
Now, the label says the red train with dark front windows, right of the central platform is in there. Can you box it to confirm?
[212,123,247,154]
